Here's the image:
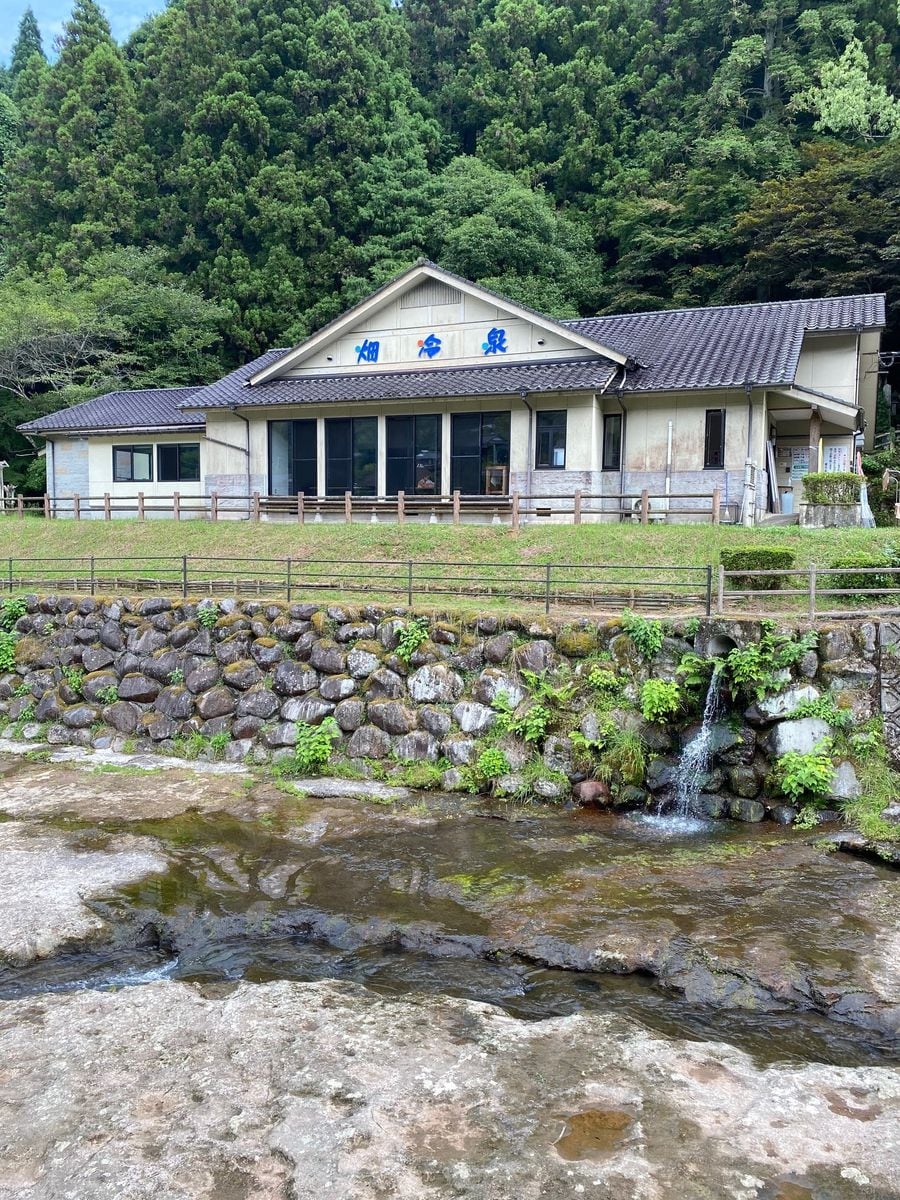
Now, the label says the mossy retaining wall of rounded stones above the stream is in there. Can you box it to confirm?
[0,596,900,820]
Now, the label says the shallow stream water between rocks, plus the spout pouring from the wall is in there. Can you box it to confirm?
[0,758,900,1063]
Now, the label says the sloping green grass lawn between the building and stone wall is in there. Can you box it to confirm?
[0,517,900,614]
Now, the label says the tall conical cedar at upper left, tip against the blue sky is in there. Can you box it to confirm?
[7,0,142,270]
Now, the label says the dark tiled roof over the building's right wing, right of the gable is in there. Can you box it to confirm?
[564,295,884,391]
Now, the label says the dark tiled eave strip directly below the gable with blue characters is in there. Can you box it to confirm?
[183,350,617,408]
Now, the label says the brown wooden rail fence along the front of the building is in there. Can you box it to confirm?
[5,488,738,530]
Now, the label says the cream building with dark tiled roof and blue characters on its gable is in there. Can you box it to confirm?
[20,263,884,515]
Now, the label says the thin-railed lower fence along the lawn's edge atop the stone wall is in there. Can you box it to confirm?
[0,554,900,618]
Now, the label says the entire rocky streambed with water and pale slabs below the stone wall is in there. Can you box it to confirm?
[0,750,900,1200]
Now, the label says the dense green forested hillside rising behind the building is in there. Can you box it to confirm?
[0,0,900,489]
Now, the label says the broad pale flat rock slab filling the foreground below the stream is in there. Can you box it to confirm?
[0,982,900,1200]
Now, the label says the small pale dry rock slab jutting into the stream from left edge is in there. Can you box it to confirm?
[0,821,168,964]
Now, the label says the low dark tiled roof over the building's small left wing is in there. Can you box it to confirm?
[19,388,204,433]
